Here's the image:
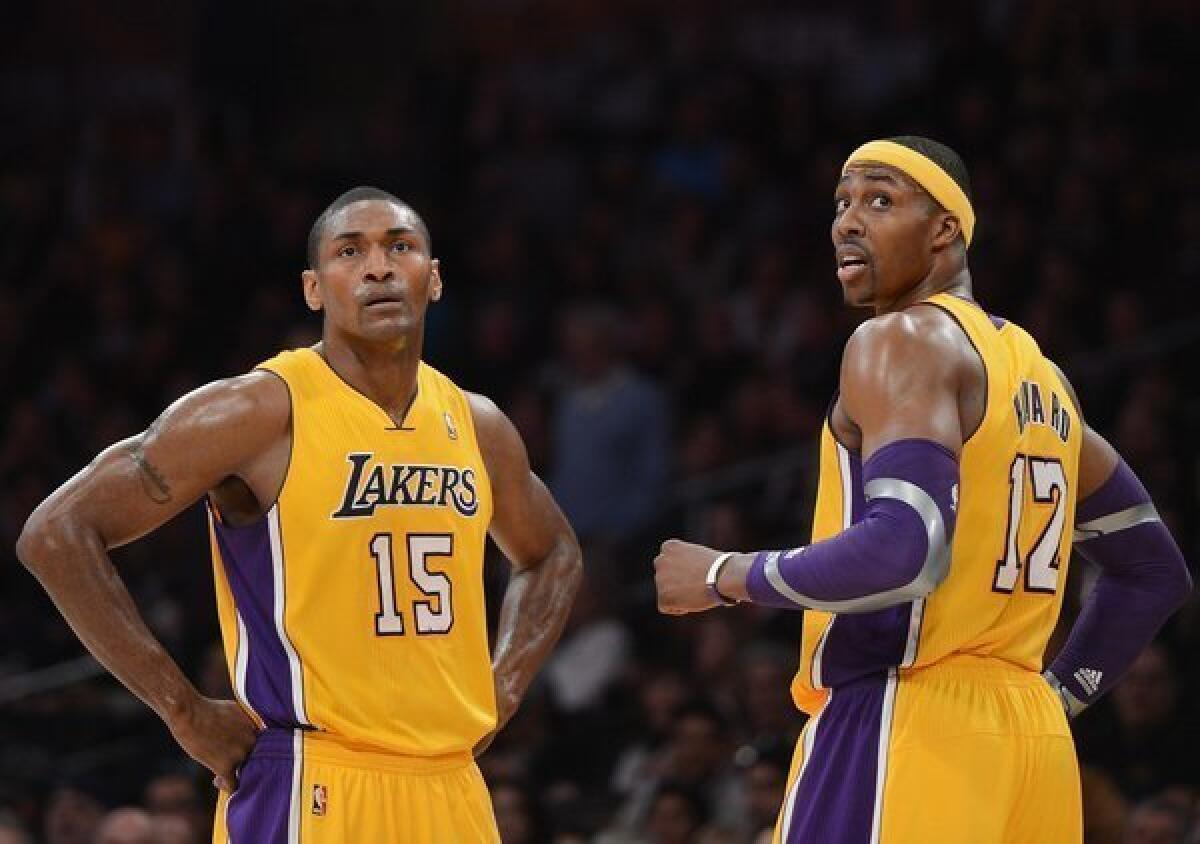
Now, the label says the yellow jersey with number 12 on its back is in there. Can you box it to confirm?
[792,294,1082,712]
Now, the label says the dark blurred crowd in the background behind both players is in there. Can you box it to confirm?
[0,0,1200,844]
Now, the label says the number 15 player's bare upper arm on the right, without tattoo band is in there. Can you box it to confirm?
[472,395,572,568]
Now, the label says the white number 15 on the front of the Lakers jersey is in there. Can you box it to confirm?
[370,533,454,636]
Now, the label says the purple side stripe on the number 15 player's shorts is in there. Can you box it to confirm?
[226,730,298,844]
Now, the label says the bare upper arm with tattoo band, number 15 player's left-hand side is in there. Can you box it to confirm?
[31,376,288,547]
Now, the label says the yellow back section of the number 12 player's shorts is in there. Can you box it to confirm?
[880,657,1084,844]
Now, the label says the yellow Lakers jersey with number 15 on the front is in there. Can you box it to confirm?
[210,348,496,755]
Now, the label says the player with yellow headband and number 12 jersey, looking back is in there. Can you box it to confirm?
[655,137,1190,844]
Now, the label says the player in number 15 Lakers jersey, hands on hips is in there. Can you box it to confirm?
[18,188,581,844]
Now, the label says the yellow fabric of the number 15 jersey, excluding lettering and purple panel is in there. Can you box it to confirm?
[214,348,496,753]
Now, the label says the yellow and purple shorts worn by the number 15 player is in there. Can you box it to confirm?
[212,730,500,844]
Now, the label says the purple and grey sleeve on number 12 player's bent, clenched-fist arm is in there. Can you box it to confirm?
[746,439,959,612]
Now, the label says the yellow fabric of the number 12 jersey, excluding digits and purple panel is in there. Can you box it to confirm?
[792,294,1082,713]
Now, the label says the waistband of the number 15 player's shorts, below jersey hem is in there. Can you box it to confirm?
[252,728,475,773]
